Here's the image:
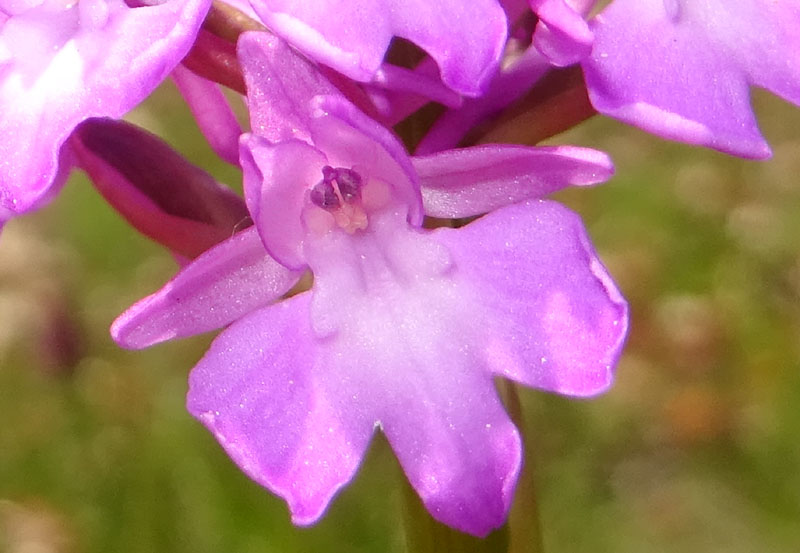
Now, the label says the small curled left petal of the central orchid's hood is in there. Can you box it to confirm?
[241,134,328,269]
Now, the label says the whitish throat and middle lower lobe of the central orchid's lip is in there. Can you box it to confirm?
[306,210,520,535]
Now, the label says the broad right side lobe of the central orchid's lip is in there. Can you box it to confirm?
[437,200,628,396]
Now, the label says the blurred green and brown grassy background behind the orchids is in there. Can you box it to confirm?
[0,83,800,553]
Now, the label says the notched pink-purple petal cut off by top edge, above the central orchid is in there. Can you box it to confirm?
[251,0,506,96]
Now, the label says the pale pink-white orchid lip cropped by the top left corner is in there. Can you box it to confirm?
[0,0,210,218]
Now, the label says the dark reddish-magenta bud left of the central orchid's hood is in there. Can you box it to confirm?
[70,118,252,259]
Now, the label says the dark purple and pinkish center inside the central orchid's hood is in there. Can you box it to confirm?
[308,165,389,234]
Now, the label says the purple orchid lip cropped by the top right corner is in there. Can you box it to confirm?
[583,0,800,158]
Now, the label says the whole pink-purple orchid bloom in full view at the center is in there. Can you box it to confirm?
[112,33,627,535]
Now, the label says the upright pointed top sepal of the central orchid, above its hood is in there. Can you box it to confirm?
[237,32,338,142]
